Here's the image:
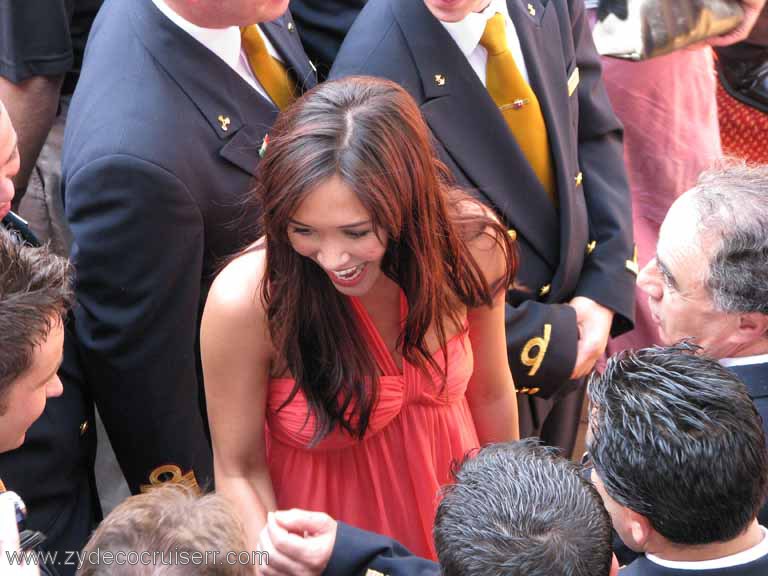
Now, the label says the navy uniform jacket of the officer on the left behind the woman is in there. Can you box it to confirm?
[62,0,315,492]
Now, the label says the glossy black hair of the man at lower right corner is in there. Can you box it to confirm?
[587,343,768,545]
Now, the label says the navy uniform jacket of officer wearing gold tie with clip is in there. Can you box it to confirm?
[331,0,637,397]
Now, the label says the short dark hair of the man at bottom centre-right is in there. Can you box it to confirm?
[434,439,611,576]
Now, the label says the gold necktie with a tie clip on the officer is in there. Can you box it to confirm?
[480,13,557,205]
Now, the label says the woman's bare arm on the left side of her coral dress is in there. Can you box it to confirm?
[200,250,276,550]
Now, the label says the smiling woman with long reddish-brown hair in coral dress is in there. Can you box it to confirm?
[201,78,518,558]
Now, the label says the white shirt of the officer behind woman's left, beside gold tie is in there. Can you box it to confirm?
[152,0,282,102]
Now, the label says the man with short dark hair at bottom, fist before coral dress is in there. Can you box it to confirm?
[260,439,618,576]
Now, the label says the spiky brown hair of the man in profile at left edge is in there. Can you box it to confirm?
[0,228,72,415]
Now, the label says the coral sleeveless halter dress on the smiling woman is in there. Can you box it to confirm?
[267,294,479,559]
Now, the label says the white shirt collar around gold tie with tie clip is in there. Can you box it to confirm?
[440,0,530,86]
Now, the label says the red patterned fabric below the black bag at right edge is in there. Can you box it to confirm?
[717,82,768,164]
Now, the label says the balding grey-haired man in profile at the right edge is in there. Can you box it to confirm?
[638,166,768,525]
